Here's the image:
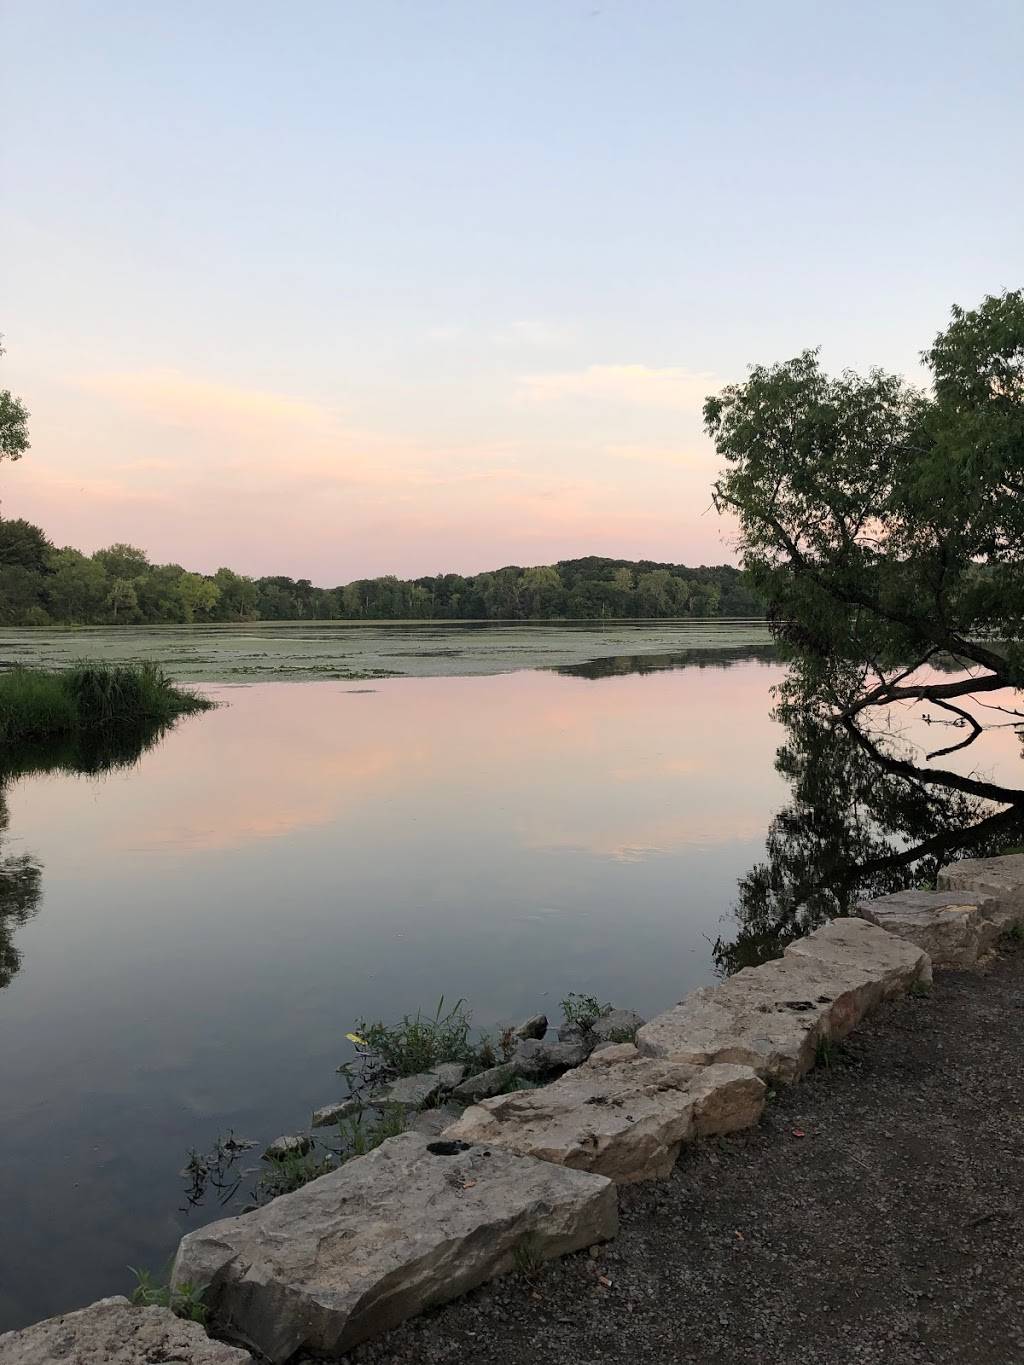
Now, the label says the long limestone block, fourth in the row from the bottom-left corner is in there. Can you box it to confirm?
[636,920,931,1082]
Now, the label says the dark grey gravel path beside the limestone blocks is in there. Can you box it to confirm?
[345,951,1024,1365]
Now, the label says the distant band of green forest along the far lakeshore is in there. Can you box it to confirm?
[0,520,763,625]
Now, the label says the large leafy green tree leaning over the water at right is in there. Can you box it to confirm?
[705,291,1024,752]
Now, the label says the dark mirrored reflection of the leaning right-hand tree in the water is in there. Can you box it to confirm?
[714,678,1024,972]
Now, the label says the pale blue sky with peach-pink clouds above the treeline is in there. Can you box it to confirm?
[0,0,1024,586]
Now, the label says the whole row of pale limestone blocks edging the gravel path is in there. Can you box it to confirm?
[10,854,1024,1365]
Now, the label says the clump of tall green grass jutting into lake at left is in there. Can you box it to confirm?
[0,663,214,745]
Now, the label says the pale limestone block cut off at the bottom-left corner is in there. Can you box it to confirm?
[0,1298,253,1365]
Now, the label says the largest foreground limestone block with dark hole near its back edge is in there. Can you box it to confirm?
[172,1133,617,1365]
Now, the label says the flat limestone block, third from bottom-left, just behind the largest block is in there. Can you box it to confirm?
[444,1046,765,1185]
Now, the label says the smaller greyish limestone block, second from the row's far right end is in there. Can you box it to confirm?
[856,891,999,966]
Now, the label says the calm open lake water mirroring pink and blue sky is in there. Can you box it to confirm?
[0,631,785,1328]
